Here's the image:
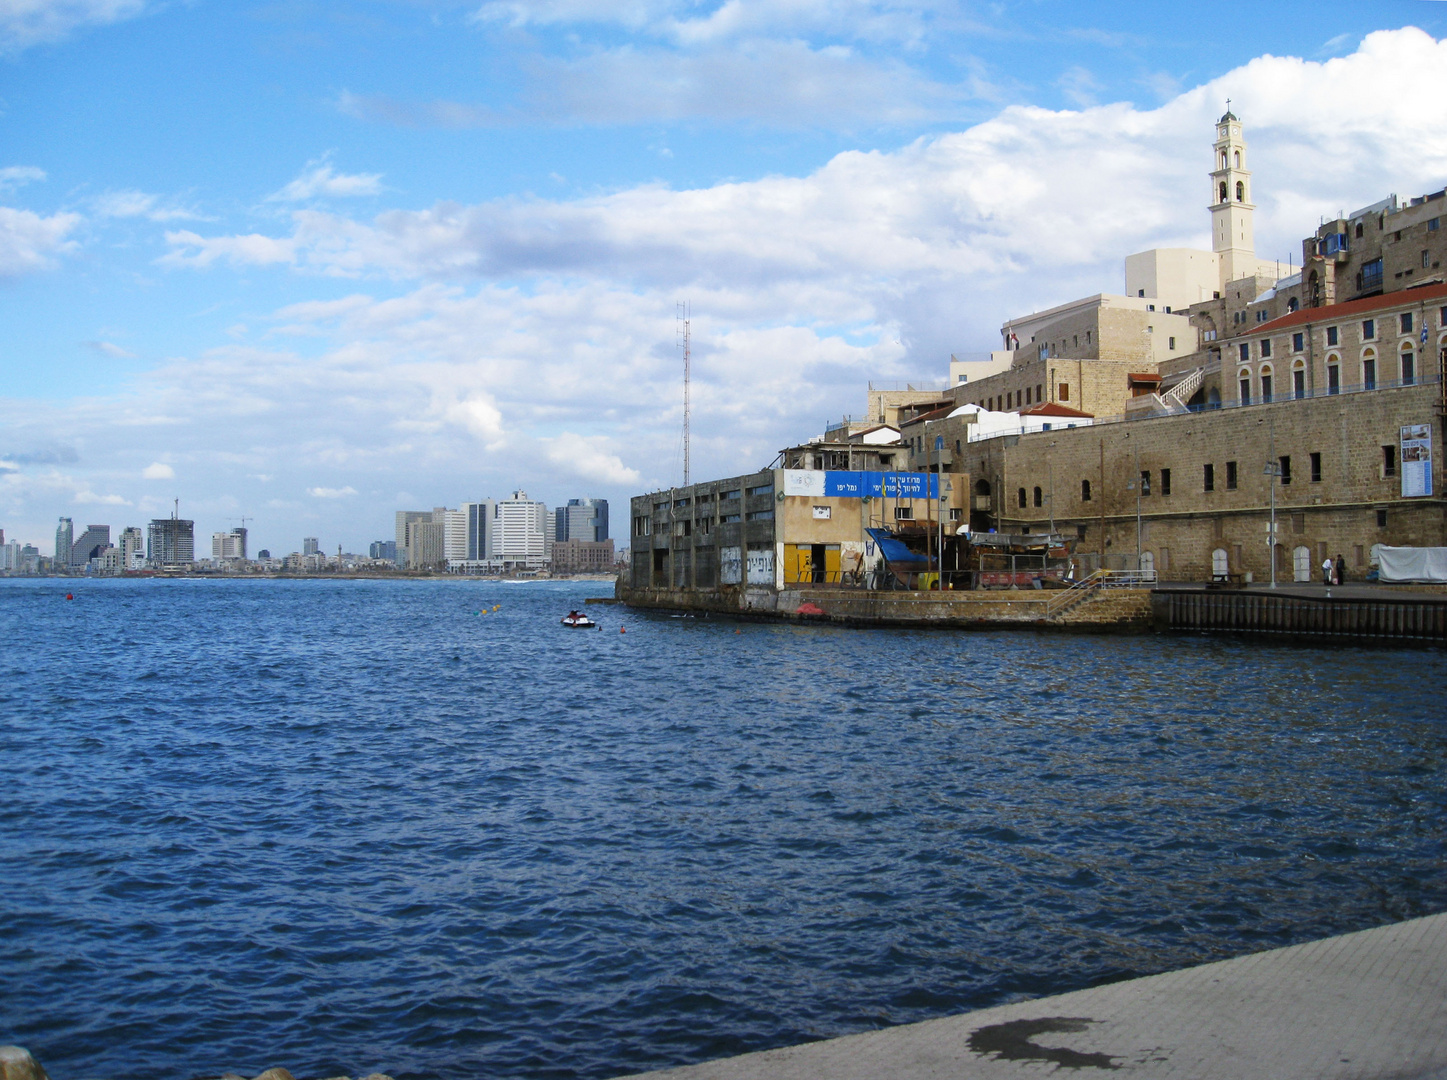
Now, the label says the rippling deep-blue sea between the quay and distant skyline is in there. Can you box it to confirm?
[0,581,1447,1080]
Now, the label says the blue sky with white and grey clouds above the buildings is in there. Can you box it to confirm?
[0,0,1447,554]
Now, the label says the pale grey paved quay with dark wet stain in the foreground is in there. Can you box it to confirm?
[619,914,1447,1080]
